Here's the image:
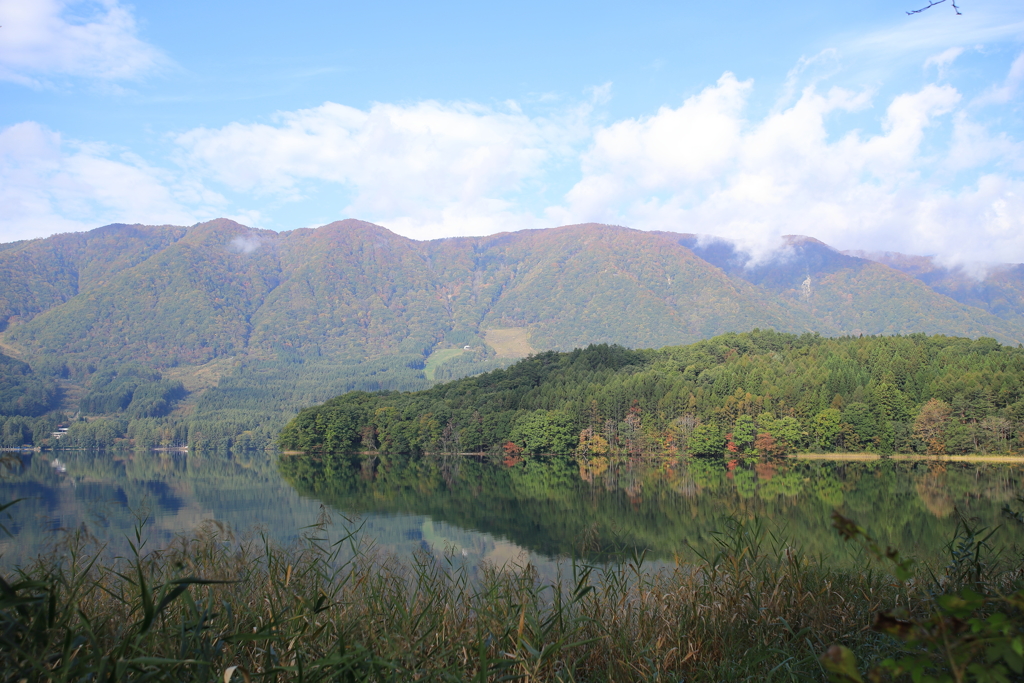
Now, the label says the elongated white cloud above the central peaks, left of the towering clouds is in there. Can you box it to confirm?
[177,101,590,237]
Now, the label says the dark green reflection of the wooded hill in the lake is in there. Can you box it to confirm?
[280,456,1024,559]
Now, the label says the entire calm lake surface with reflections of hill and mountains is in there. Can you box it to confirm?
[0,452,1024,574]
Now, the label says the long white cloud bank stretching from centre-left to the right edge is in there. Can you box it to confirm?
[167,65,1024,260]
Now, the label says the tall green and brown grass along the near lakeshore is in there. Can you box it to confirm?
[0,509,1015,682]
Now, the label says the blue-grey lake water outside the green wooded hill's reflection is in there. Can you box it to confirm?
[0,452,553,575]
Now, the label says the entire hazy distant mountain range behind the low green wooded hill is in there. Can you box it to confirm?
[0,218,1024,450]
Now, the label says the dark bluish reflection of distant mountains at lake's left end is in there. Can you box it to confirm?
[0,452,318,564]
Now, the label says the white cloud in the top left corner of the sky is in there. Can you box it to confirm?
[0,0,168,85]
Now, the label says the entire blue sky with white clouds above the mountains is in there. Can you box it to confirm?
[0,0,1024,262]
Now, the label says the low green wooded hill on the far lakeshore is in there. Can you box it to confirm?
[280,330,1024,459]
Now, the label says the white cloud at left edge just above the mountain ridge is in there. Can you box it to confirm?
[0,122,209,242]
